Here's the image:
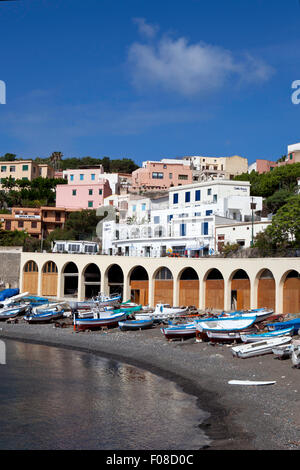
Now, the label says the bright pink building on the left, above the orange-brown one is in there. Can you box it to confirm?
[56,180,112,210]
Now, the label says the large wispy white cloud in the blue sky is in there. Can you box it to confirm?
[128,27,273,96]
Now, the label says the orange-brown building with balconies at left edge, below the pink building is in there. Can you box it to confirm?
[0,206,68,239]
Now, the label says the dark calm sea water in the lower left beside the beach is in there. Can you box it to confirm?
[0,340,209,450]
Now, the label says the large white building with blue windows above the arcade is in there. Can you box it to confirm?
[103,180,262,257]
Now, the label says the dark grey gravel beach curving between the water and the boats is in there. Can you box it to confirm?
[0,321,300,450]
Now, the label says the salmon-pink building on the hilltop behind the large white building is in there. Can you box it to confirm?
[132,160,193,190]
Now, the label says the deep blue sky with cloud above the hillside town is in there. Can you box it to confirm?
[0,0,300,164]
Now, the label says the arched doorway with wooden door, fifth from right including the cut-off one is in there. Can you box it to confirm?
[179,268,199,308]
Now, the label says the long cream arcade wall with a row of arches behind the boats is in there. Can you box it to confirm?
[19,252,300,313]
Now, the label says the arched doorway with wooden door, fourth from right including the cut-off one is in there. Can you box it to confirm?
[205,269,224,310]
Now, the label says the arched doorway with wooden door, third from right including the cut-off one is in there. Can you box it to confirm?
[231,269,250,310]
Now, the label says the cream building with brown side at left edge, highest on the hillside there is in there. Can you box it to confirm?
[0,160,54,189]
